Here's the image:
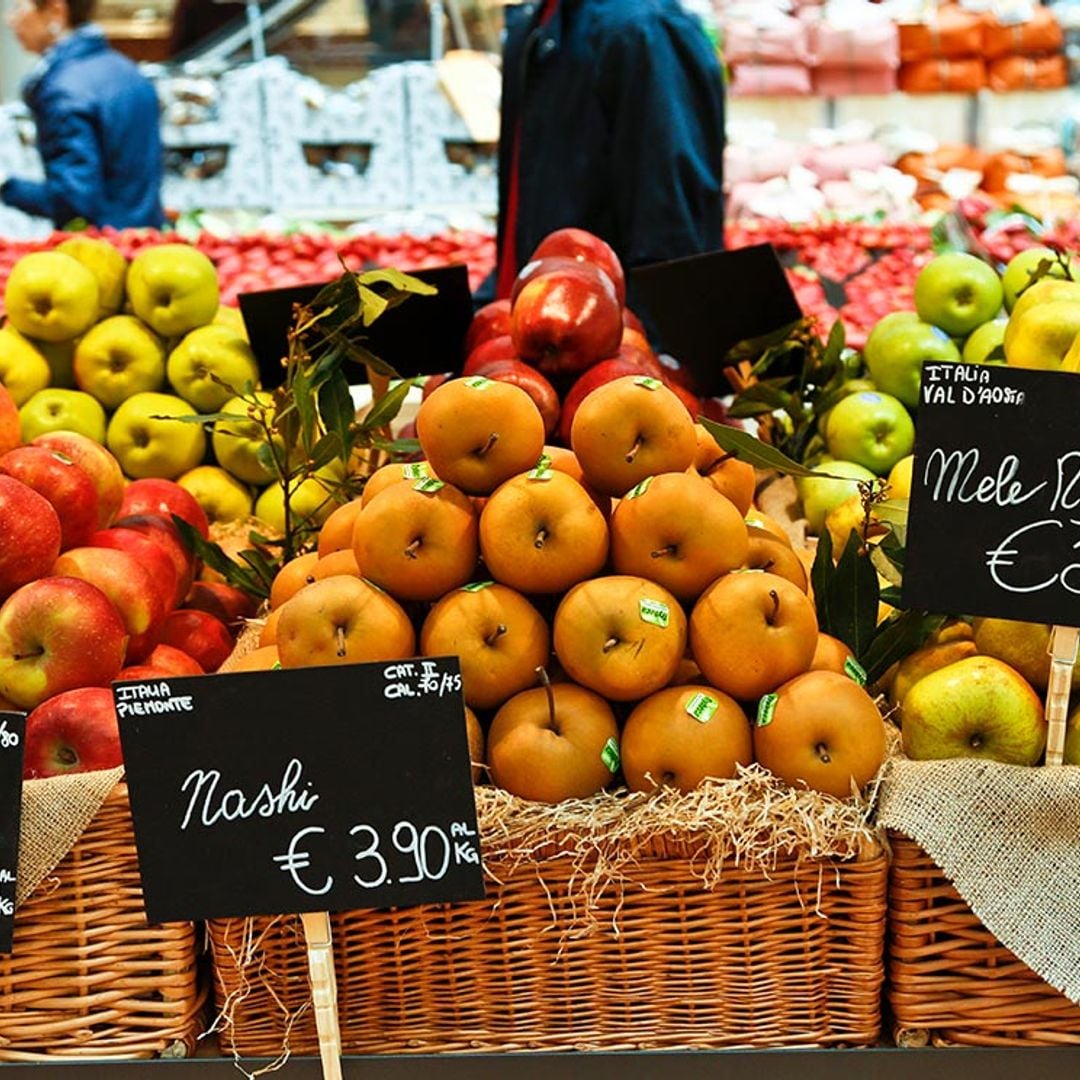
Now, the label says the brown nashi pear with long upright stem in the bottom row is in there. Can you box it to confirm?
[487,683,619,804]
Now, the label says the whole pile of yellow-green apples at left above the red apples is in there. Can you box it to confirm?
[0,237,304,529]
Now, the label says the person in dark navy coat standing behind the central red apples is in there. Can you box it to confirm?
[495,0,725,306]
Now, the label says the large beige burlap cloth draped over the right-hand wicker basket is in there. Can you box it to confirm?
[877,758,1080,1004]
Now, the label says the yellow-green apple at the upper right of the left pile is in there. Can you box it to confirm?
[127,244,218,338]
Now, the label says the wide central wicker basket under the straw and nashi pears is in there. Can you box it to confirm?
[208,852,888,1055]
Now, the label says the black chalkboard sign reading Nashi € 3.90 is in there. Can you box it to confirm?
[112,657,484,922]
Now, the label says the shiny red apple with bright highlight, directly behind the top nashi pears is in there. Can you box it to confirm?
[511,262,622,376]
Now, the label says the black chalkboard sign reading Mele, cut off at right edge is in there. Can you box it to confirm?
[903,363,1080,626]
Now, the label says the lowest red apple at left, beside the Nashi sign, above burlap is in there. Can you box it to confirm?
[23,686,123,780]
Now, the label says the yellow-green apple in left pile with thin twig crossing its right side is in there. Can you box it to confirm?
[106,391,206,480]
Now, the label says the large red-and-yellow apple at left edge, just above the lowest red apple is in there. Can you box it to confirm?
[0,577,127,708]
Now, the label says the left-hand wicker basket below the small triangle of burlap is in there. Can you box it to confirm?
[0,784,206,1062]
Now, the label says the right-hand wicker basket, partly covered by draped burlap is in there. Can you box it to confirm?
[887,832,1080,1047]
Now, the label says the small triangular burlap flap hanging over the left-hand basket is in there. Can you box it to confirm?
[15,769,124,906]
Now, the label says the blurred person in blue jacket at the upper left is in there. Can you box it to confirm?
[0,0,164,229]
